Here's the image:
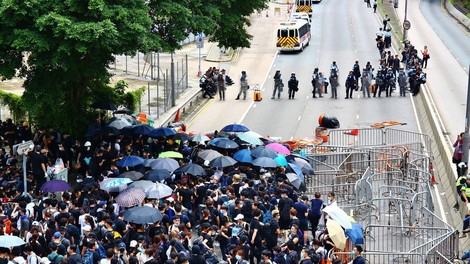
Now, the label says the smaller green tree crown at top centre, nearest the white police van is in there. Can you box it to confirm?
[149,0,267,51]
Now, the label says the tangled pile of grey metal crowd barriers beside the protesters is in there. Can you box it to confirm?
[302,128,458,263]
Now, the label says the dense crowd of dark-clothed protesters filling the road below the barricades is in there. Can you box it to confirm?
[0,116,364,264]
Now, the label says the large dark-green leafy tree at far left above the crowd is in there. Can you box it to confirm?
[0,0,155,135]
